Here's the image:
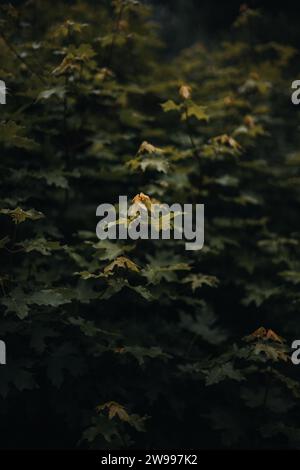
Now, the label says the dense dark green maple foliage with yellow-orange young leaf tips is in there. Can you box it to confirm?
[0,0,300,449]
